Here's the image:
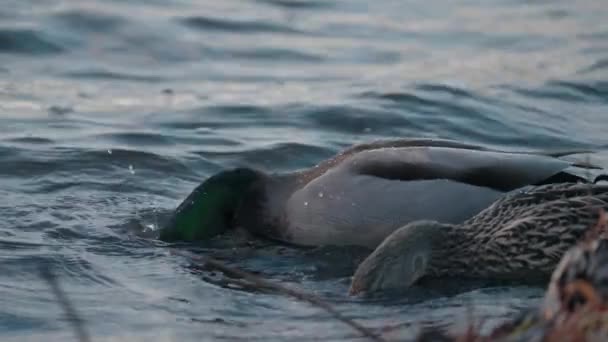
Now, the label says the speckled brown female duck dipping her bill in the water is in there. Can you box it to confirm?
[350,183,608,294]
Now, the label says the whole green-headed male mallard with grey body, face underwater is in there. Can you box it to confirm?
[160,139,604,248]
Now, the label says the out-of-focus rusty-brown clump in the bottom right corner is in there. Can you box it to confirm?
[416,232,608,342]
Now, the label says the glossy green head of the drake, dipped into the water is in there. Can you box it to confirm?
[159,168,260,242]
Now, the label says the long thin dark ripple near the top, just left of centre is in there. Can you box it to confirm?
[180,16,300,34]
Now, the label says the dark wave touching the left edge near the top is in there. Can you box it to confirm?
[0,29,64,55]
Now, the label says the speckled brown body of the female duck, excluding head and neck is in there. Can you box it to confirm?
[462,184,608,276]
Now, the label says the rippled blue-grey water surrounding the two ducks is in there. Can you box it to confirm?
[0,0,608,341]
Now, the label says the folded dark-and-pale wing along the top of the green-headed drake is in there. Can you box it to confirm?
[338,146,600,192]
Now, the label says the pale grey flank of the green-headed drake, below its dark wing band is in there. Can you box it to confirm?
[286,168,503,248]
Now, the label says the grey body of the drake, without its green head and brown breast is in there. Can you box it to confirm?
[268,140,604,248]
